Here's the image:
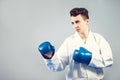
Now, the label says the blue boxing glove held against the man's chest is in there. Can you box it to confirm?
[73,47,92,65]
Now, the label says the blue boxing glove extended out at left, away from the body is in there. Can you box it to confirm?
[38,41,55,59]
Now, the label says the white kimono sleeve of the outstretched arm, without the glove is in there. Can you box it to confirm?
[45,40,69,71]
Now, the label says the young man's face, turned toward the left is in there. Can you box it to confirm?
[71,15,89,33]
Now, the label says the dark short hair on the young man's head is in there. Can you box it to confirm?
[70,8,89,19]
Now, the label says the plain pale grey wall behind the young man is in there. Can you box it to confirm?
[0,0,120,80]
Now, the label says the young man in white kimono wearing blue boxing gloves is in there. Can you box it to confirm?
[38,8,113,80]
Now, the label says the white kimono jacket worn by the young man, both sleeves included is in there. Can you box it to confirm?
[45,31,113,80]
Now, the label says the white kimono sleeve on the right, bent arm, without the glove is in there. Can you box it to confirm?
[89,35,113,68]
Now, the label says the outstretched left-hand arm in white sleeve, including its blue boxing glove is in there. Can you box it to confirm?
[38,42,68,71]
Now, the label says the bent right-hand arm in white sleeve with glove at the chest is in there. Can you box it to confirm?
[73,37,113,68]
